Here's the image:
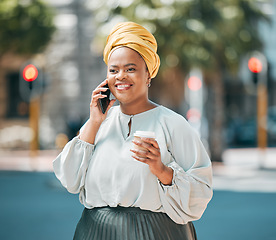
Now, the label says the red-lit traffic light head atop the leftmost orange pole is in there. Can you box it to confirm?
[19,63,43,102]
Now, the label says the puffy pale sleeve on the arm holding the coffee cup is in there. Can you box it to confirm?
[159,114,213,224]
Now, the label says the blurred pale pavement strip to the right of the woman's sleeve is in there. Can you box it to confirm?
[213,148,276,192]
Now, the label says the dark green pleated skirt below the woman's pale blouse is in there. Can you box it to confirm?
[74,207,197,240]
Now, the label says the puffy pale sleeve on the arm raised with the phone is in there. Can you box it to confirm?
[53,137,94,193]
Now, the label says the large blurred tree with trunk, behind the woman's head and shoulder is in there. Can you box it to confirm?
[91,0,267,161]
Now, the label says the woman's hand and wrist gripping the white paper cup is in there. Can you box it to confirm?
[130,138,173,185]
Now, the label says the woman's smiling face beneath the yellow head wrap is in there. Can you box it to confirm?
[107,47,150,111]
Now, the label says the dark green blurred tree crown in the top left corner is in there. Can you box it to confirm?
[0,0,55,58]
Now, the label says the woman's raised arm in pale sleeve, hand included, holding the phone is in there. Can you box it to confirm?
[53,80,115,193]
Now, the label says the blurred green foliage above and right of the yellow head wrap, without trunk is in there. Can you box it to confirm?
[91,0,267,74]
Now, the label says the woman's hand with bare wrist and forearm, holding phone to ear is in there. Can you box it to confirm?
[80,79,116,144]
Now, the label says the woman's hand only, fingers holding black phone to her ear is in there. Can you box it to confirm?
[89,79,116,124]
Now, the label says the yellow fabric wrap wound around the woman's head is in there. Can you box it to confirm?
[103,22,160,78]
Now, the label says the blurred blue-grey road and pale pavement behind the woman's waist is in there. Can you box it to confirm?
[0,148,276,240]
